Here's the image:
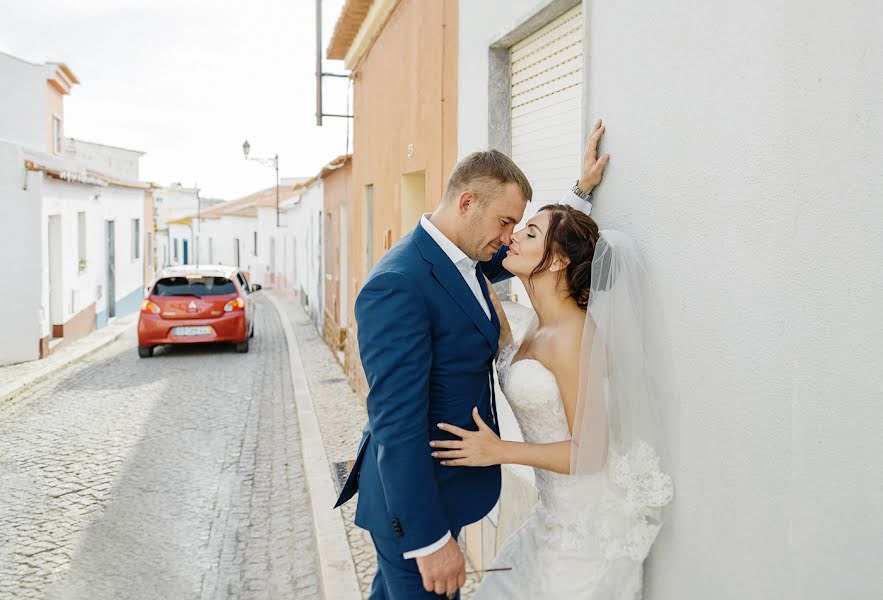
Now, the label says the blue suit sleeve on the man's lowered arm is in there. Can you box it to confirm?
[355,272,449,552]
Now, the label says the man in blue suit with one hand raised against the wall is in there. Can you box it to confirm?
[335,122,607,600]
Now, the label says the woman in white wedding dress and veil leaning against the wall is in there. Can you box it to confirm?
[430,200,673,600]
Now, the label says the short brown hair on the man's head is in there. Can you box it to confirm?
[444,150,533,203]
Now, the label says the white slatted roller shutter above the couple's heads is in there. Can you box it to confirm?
[510,6,585,304]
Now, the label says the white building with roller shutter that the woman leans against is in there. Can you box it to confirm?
[458,0,883,600]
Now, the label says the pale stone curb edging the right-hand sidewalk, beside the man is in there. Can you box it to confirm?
[265,294,362,600]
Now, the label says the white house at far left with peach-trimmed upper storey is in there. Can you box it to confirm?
[0,53,150,364]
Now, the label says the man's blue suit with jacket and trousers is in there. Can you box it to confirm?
[336,224,511,599]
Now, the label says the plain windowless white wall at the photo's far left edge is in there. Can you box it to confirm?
[0,143,43,365]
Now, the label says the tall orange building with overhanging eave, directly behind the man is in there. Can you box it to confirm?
[327,0,458,397]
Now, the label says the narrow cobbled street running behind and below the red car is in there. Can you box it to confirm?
[0,295,321,600]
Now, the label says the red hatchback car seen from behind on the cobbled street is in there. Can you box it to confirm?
[138,265,261,358]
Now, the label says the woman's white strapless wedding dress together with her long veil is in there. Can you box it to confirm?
[475,232,673,600]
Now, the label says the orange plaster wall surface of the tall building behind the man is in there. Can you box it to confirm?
[347,0,458,393]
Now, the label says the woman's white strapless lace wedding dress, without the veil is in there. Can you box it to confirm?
[476,346,673,600]
